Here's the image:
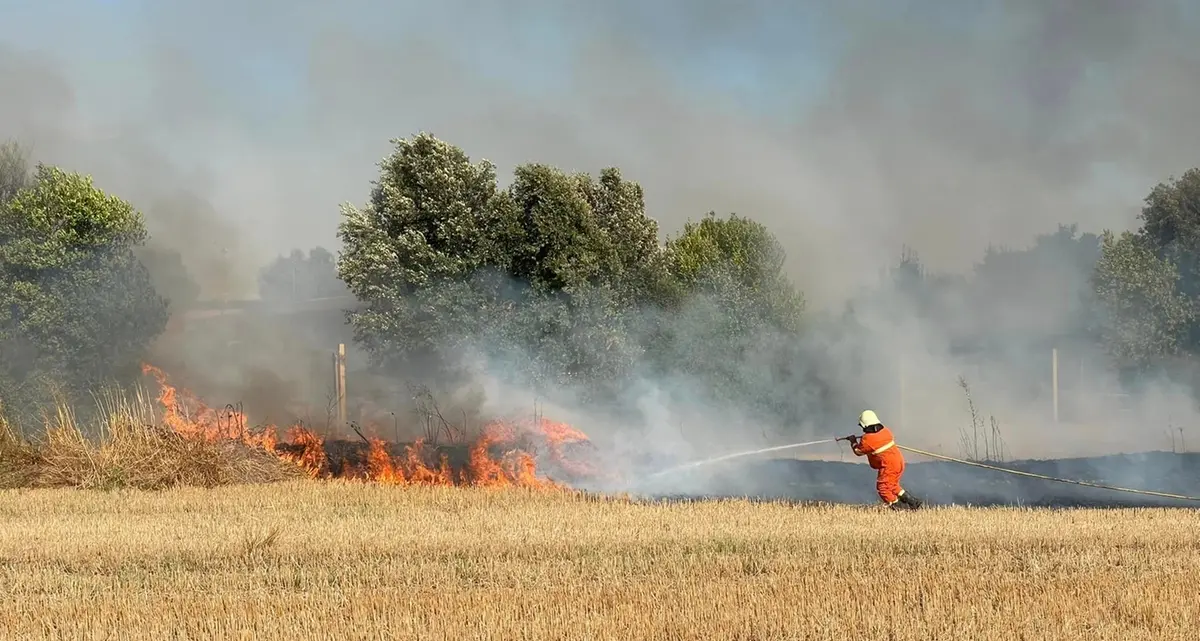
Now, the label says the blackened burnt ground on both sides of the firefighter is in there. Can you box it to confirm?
[637,453,1200,508]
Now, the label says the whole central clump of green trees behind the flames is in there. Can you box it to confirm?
[338,134,803,412]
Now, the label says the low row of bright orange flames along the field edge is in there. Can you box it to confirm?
[136,365,588,490]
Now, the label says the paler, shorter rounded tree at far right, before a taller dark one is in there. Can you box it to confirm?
[1093,232,1196,369]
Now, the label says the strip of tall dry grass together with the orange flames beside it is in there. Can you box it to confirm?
[0,365,600,490]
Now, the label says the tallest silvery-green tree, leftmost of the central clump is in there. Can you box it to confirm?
[337,133,521,366]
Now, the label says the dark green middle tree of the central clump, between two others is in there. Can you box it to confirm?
[496,164,667,391]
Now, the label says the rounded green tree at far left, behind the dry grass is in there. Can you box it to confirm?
[0,166,168,420]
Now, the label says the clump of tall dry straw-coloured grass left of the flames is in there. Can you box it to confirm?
[0,393,302,490]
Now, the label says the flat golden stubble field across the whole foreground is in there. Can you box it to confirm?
[0,481,1200,641]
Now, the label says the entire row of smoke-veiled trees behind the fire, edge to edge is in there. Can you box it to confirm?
[0,134,1200,429]
